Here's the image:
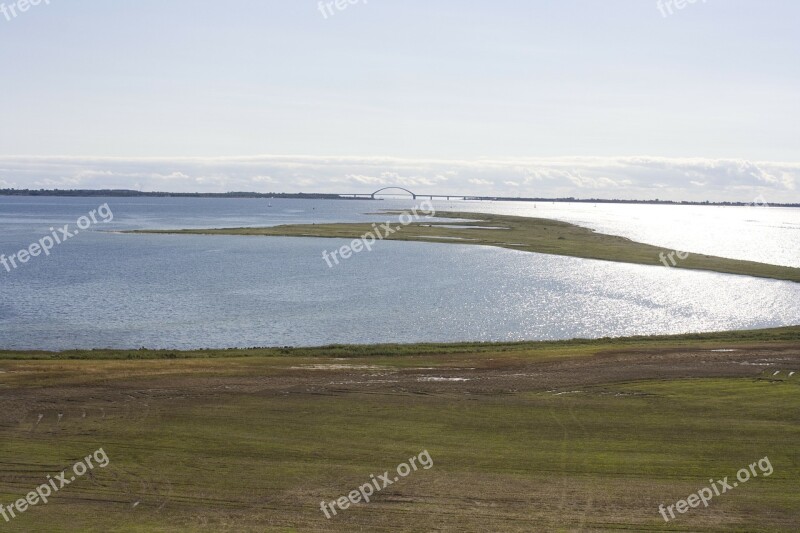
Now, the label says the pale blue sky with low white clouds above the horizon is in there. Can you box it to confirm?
[0,0,800,203]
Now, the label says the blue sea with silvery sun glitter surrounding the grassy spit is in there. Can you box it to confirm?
[0,197,800,350]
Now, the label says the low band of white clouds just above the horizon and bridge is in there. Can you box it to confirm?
[0,156,800,203]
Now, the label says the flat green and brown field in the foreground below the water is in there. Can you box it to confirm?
[0,327,800,532]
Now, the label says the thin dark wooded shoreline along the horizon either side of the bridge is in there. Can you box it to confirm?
[0,189,800,207]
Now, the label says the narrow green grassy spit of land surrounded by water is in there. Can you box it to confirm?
[128,212,800,282]
